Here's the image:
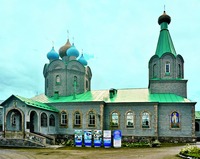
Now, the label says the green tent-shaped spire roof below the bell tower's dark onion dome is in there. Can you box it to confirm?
[155,22,176,58]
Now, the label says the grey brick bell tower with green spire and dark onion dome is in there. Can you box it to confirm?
[148,11,187,97]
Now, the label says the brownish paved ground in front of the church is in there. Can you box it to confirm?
[0,143,200,159]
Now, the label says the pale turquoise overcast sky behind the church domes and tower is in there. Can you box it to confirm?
[0,0,200,110]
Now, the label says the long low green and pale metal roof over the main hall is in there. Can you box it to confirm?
[32,88,191,103]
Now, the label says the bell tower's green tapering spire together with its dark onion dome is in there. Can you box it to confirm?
[156,11,176,58]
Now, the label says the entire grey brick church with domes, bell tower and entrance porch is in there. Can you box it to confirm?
[1,11,199,143]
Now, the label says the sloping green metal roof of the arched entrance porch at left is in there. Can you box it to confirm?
[14,95,59,112]
